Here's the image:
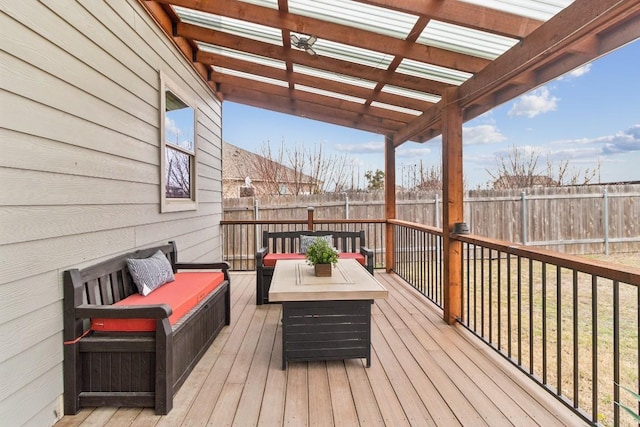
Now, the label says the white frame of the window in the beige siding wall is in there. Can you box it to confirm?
[159,72,198,212]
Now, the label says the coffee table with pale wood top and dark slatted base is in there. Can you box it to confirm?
[269,259,388,369]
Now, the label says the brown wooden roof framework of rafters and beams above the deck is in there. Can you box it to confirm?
[141,0,640,146]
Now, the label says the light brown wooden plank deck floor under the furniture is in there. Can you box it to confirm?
[56,272,584,427]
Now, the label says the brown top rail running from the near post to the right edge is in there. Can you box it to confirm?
[451,234,640,286]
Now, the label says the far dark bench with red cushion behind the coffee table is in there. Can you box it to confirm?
[256,230,373,305]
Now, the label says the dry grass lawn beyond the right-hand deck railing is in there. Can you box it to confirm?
[463,251,640,425]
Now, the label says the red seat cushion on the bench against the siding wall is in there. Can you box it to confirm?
[91,272,224,332]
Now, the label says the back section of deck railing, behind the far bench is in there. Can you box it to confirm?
[220,215,385,271]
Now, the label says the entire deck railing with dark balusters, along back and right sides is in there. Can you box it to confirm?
[221,220,640,425]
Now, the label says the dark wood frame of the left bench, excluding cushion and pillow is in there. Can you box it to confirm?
[64,242,230,414]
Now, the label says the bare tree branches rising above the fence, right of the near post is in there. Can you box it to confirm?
[486,145,600,189]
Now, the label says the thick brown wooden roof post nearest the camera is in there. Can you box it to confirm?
[442,87,464,325]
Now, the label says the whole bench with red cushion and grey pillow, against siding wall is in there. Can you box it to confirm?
[63,242,231,414]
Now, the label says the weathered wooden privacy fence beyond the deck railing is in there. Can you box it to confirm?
[223,184,640,260]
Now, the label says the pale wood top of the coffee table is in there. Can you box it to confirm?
[269,259,388,302]
